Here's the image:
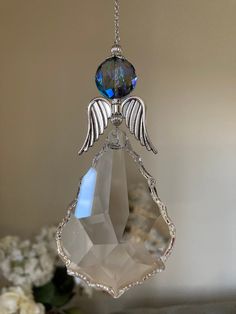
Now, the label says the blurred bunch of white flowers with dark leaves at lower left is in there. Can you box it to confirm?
[0,227,92,314]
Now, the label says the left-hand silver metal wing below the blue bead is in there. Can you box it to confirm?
[79,97,111,155]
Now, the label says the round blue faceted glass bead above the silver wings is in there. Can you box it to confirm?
[95,56,137,99]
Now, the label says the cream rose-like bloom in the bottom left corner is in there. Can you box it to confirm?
[0,287,45,314]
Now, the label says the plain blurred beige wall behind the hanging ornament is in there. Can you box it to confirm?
[0,0,236,313]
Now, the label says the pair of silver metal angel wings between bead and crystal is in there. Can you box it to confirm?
[79,94,157,155]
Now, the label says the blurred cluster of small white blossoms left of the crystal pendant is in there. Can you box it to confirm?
[0,227,57,286]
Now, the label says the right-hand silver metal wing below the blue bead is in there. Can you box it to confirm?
[121,96,157,154]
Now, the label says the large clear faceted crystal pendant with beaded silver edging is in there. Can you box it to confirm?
[57,129,175,297]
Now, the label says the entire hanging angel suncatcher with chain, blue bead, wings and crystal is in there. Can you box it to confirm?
[56,0,175,297]
